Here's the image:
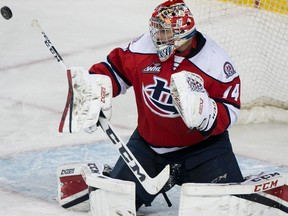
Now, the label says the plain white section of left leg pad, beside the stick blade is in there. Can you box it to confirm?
[82,167,136,216]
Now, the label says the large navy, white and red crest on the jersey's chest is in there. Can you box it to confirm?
[142,77,179,118]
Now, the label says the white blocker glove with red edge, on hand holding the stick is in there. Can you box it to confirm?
[59,67,112,133]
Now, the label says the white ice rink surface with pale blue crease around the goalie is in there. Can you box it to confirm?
[0,0,288,216]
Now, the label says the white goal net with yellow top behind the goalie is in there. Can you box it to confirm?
[186,0,288,123]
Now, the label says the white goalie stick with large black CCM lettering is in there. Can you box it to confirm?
[32,19,170,194]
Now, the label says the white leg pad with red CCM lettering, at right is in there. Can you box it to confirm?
[178,172,288,216]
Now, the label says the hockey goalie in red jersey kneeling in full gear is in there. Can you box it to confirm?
[57,0,288,216]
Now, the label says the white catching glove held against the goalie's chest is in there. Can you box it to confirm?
[170,71,218,131]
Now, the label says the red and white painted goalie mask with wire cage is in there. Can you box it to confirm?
[149,0,196,62]
